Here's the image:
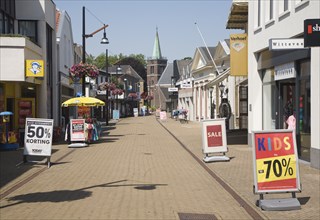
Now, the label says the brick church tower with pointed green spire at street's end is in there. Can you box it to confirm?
[147,28,168,107]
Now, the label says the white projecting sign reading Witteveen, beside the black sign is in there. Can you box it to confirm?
[269,38,304,50]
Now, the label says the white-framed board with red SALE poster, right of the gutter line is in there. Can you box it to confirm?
[201,118,228,154]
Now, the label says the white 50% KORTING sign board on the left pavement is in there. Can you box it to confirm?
[23,118,53,156]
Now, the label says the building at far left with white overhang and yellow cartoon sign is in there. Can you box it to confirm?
[0,0,57,129]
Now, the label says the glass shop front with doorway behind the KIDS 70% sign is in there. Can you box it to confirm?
[258,49,311,161]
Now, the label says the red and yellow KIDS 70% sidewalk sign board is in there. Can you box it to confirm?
[253,130,301,193]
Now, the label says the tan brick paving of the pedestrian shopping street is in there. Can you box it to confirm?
[0,116,320,219]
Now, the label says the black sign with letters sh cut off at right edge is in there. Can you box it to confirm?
[304,19,320,47]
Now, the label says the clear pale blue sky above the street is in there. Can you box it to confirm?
[53,0,243,62]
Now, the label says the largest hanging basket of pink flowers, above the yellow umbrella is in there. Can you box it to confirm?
[69,62,99,80]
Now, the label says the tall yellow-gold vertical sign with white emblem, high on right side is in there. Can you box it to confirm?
[230,34,248,76]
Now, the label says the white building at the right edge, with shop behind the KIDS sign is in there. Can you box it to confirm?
[248,0,320,168]
